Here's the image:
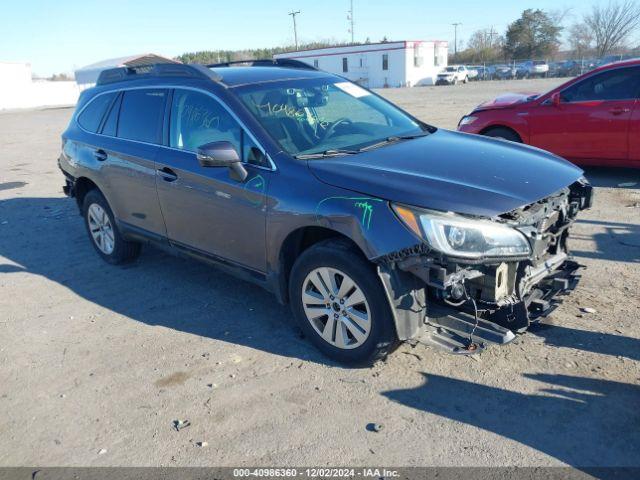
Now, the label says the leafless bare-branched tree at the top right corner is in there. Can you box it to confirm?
[584,0,640,57]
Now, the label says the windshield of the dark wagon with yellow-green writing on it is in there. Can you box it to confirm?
[238,78,425,156]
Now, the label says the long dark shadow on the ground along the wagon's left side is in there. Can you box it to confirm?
[0,198,334,365]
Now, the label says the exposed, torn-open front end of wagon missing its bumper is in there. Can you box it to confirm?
[378,180,593,354]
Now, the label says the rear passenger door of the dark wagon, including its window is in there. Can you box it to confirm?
[97,88,168,236]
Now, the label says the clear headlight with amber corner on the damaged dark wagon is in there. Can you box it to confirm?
[392,205,531,259]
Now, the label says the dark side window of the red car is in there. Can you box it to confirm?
[560,67,640,102]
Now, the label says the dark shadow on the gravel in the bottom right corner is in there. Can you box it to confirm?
[383,373,640,468]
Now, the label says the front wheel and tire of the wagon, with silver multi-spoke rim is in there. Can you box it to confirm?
[289,240,399,365]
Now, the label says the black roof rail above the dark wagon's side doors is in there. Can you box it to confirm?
[96,63,220,85]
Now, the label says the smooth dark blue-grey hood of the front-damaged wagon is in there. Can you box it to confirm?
[308,130,583,217]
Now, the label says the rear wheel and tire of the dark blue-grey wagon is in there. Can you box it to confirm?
[82,190,140,265]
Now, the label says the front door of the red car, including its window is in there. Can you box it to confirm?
[529,67,640,164]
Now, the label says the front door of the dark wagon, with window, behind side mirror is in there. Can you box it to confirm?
[156,89,272,272]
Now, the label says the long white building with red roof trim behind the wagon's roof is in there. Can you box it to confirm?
[273,40,449,88]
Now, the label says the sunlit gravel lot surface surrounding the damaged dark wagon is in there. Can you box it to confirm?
[0,79,640,466]
